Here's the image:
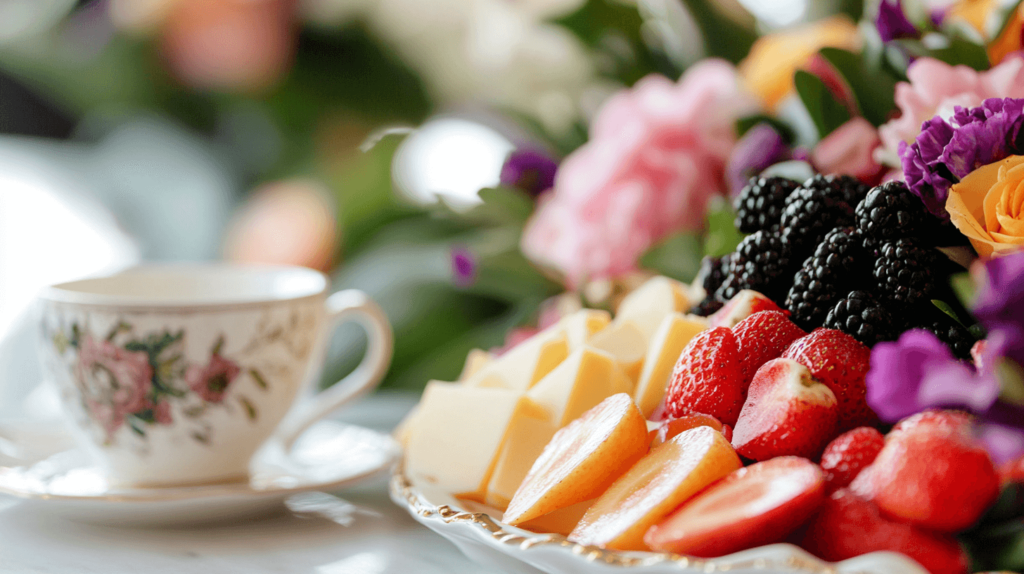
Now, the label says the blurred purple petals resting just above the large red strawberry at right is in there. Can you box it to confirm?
[866,329,999,423]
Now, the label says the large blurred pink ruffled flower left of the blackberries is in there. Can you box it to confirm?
[522,59,757,286]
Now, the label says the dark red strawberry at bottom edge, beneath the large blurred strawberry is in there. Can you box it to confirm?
[800,488,970,574]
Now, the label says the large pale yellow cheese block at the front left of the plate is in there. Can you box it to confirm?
[406,381,548,501]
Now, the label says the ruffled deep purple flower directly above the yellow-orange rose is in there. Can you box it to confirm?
[899,98,1024,219]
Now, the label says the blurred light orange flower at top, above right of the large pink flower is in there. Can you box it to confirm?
[739,16,860,108]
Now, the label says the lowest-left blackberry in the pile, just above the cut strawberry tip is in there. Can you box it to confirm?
[716,230,793,303]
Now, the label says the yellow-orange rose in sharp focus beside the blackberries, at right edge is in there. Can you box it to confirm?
[946,156,1024,257]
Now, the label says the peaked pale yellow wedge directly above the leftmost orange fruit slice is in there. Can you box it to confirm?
[523,347,633,427]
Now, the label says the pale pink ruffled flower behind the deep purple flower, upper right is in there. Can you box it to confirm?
[876,57,1024,166]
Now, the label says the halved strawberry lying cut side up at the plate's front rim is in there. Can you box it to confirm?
[644,456,825,558]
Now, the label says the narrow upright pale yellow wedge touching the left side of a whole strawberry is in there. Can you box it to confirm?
[633,313,708,418]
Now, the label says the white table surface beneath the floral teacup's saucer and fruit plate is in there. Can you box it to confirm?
[0,393,484,574]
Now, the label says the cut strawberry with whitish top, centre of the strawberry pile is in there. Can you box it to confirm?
[732,359,838,460]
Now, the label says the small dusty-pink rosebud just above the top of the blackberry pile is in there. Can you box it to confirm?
[811,118,882,183]
